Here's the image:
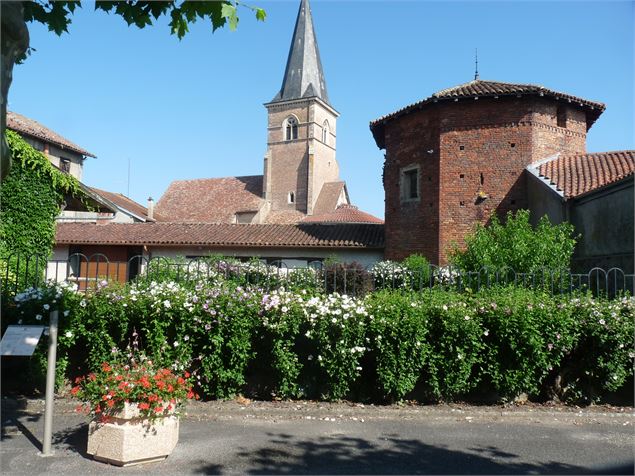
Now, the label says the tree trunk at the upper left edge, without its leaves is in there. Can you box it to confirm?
[0,1,29,180]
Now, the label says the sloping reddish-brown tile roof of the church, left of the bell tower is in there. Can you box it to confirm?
[155,175,263,223]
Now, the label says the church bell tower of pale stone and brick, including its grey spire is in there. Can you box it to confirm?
[263,0,339,216]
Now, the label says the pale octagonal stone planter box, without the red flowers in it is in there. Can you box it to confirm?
[87,403,179,466]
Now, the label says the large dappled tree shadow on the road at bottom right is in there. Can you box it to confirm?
[193,433,632,474]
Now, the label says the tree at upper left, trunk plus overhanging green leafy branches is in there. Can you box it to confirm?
[0,0,266,180]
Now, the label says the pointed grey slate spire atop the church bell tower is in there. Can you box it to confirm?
[272,0,330,105]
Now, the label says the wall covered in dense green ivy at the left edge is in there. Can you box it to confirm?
[0,131,83,259]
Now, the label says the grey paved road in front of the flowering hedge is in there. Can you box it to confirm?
[0,401,635,475]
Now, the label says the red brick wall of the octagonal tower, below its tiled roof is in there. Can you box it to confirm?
[384,93,586,264]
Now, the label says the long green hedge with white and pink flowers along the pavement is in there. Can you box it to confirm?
[3,281,635,402]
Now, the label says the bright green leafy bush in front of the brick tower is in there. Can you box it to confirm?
[450,210,576,273]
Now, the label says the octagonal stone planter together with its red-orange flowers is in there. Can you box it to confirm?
[71,355,198,466]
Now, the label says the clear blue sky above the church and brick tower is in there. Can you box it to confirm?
[9,0,635,218]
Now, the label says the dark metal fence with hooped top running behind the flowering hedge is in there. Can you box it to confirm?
[0,253,635,296]
